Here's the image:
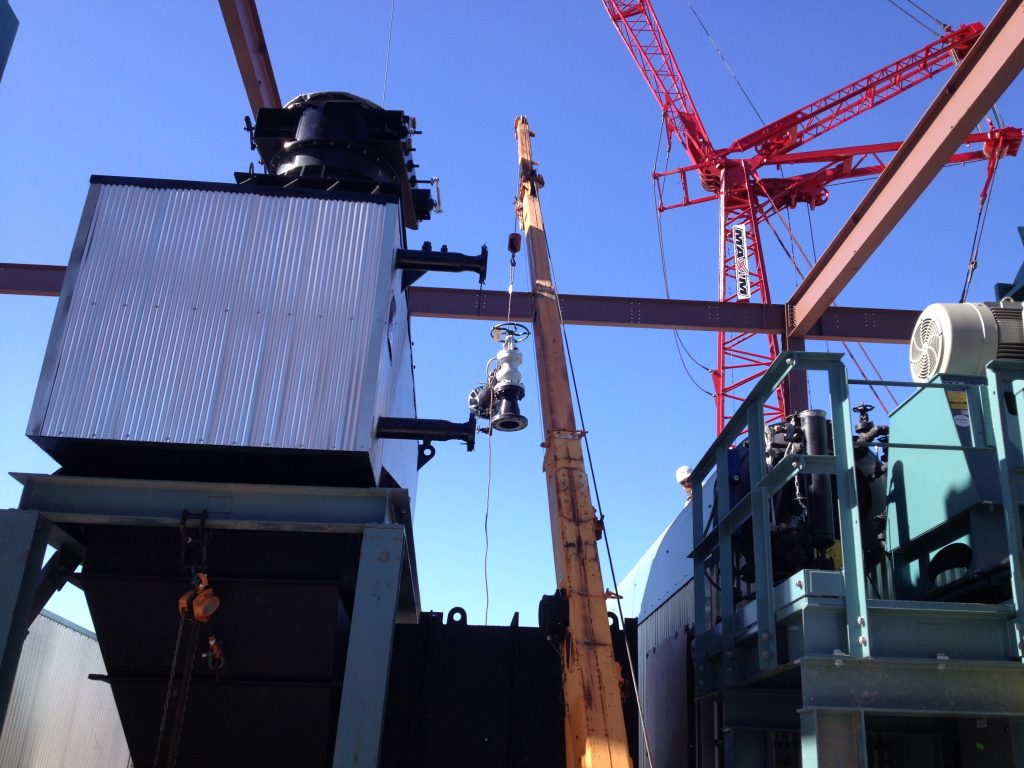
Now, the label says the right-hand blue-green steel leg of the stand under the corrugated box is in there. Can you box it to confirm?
[333,525,406,768]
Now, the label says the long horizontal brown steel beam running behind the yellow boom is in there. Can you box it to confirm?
[0,263,919,344]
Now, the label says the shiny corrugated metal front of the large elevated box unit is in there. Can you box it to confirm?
[30,183,399,451]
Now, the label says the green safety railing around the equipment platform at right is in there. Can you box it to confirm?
[690,351,1024,685]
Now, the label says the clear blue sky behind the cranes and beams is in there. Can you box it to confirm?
[0,0,1024,624]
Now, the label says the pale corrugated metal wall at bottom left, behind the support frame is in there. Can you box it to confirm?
[0,614,130,768]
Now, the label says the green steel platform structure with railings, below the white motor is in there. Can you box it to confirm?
[690,351,1024,767]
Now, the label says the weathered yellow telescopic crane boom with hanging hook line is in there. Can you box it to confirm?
[515,116,632,768]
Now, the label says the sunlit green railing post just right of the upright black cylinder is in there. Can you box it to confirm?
[825,362,871,657]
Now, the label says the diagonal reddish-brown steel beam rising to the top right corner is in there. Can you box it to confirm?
[788,0,1024,337]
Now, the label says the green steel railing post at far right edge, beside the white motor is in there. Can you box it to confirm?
[986,362,1024,656]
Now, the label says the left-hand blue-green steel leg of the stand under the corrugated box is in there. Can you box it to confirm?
[0,509,50,730]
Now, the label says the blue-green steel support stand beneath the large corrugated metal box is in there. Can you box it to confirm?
[0,474,419,766]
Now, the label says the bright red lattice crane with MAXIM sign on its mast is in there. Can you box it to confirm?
[602,0,1021,431]
